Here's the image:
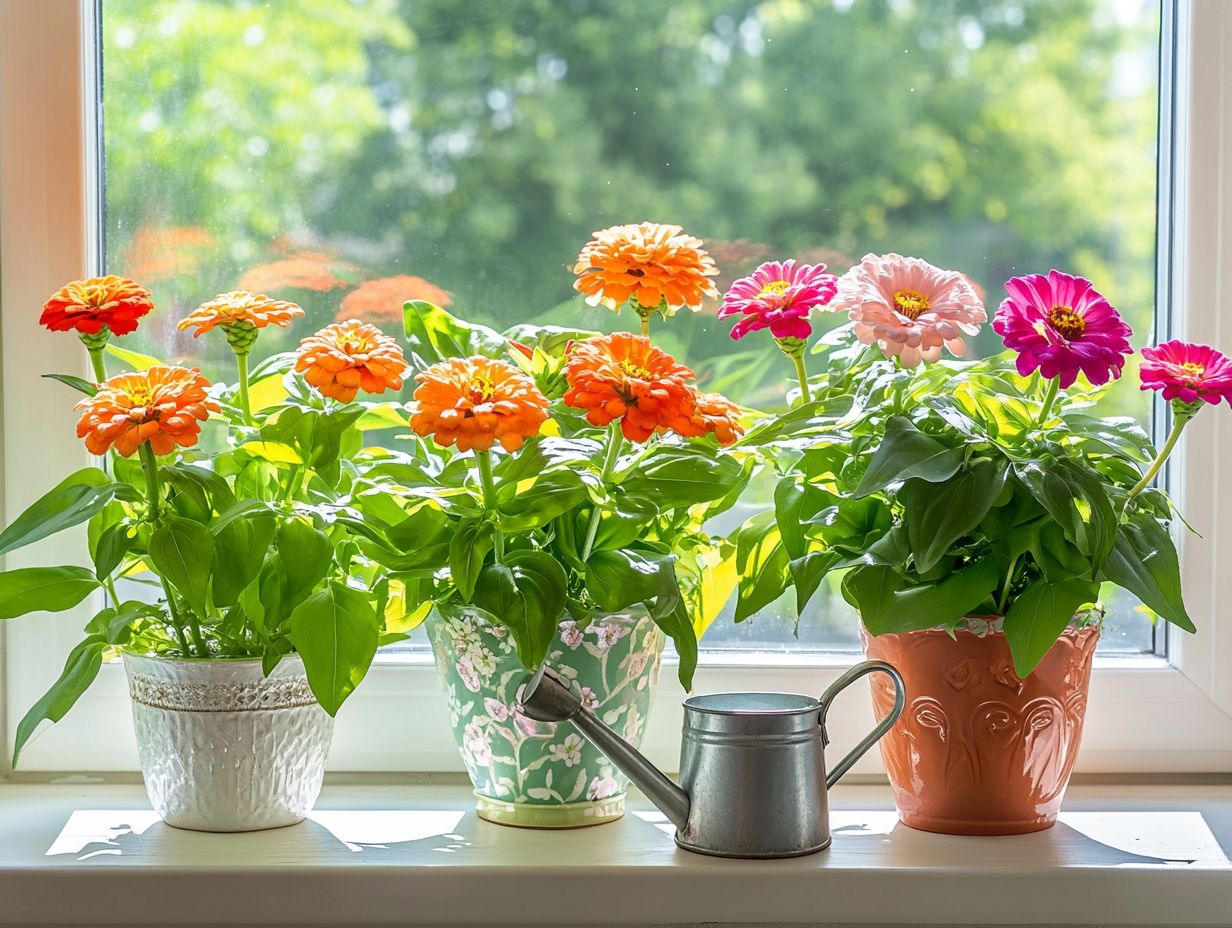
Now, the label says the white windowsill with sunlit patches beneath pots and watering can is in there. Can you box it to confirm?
[0,784,1232,927]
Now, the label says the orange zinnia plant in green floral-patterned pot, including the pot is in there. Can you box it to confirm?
[356,227,748,828]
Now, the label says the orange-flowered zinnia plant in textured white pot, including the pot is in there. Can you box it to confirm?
[0,277,405,831]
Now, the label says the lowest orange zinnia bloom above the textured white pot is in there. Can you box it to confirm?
[76,366,218,457]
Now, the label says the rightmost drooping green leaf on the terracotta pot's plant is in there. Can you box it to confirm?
[1103,509,1198,632]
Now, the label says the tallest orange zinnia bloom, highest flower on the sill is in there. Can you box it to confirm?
[573,222,718,314]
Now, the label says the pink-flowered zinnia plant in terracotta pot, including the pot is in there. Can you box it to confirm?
[738,255,1232,834]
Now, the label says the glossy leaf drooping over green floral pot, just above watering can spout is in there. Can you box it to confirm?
[474,551,568,670]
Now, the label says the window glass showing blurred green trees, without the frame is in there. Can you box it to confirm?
[102,0,1159,652]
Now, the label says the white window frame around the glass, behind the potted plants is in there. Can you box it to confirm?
[0,0,1232,776]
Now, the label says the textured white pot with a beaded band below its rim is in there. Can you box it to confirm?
[124,653,334,832]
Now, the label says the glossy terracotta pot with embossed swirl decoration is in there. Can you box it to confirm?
[861,626,1099,834]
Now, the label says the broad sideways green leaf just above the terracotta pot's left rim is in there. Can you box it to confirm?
[843,557,1000,635]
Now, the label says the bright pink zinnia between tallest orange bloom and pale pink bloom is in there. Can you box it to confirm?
[718,260,838,339]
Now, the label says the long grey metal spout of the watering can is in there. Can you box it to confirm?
[517,667,689,834]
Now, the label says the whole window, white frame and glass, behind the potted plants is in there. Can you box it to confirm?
[0,0,1232,770]
